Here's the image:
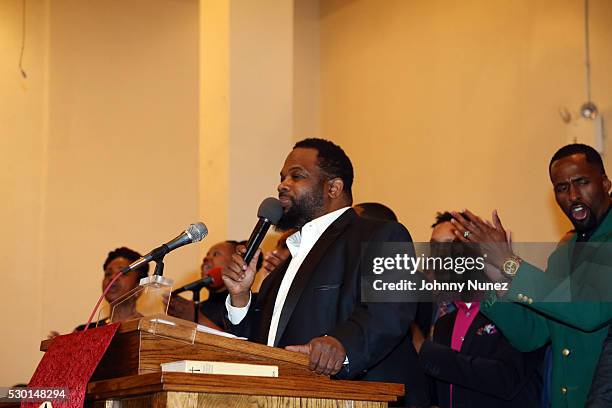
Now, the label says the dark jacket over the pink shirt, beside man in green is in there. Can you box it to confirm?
[419,311,544,408]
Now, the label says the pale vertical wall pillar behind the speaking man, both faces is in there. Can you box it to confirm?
[200,0,294,248]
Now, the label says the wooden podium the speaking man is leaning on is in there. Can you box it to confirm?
[41,316,404,408]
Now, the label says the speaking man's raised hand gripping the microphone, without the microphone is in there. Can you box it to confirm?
[222,245,261,307]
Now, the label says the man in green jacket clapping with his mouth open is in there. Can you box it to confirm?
[453,144,612,408]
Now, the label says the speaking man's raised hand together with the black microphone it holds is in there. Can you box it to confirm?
[223,197,283,307]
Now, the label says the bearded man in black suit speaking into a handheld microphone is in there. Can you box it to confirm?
[223,139,428,406]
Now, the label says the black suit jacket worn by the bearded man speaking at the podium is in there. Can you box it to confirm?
[227,209,429,406]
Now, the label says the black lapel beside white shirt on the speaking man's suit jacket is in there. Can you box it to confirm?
[274,208,357,346]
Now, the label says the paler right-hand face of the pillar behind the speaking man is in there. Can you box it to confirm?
[228,0,293,240]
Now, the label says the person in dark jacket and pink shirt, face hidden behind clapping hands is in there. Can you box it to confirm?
[413,212,543,408]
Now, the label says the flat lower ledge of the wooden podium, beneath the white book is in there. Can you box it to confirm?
[86,373,403,408]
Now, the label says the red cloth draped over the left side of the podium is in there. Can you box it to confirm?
[21,323,120,408]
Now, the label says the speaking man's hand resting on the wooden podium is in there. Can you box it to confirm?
[285,336,346,375]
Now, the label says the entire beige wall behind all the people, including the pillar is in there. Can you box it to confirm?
[0,0,612,384]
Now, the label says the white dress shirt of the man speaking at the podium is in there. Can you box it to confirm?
[225,207,350,346]
